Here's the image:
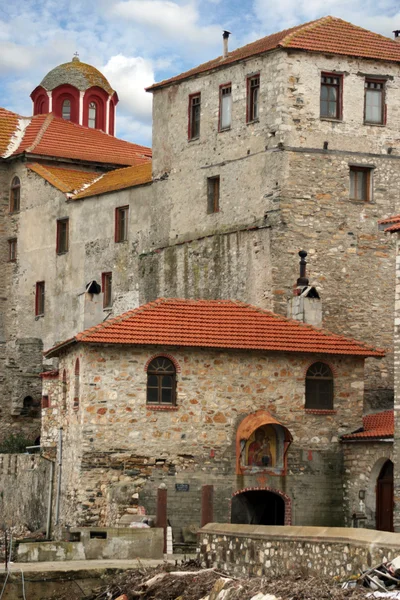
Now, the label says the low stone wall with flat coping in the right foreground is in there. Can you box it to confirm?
[198,523,400,579]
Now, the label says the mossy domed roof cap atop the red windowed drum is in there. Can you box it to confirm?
[40,56,114,95]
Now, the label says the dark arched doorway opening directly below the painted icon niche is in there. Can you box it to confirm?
[231,490,285,525]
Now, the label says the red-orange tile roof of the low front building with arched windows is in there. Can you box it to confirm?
[46,298,384,357]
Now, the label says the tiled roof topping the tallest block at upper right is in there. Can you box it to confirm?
[147,16,400,90]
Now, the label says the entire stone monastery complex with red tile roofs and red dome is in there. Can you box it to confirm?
[0,17,400,537]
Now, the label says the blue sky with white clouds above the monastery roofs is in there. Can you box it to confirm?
[0,0,400,145]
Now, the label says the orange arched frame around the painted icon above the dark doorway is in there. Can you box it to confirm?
[236,409,293,475]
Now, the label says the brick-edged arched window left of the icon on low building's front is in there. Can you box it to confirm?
[147,356,176,405]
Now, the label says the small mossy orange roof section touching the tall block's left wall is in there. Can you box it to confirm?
[73,161,152,200]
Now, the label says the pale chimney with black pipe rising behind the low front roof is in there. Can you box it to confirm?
[287,250,322,327]
